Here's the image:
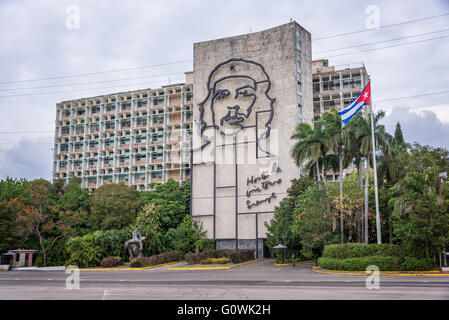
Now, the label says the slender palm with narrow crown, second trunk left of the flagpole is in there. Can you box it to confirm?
[320,108,345,243]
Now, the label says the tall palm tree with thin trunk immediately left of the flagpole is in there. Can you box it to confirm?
[350,111,390,243]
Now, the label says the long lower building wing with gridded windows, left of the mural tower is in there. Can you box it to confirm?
[53,73,193,190]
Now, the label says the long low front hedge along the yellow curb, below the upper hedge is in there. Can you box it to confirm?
[318,256,434,271]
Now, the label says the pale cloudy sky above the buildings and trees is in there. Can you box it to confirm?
[0,0,449,179]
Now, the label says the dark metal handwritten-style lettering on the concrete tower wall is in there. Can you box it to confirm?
[246,162,282,209]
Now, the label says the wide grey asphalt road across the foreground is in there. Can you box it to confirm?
[0,260,449,300]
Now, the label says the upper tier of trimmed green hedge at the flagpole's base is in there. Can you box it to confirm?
[323,243,405,259]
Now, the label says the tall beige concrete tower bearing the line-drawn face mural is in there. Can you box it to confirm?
[191,22,313,257]
